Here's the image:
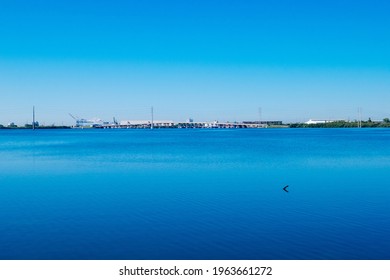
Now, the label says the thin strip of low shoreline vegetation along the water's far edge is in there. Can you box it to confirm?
[0,118,390,129]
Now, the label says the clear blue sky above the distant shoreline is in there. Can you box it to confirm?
[0,0,390,124]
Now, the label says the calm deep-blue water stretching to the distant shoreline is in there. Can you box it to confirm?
[0,129,390,259]
